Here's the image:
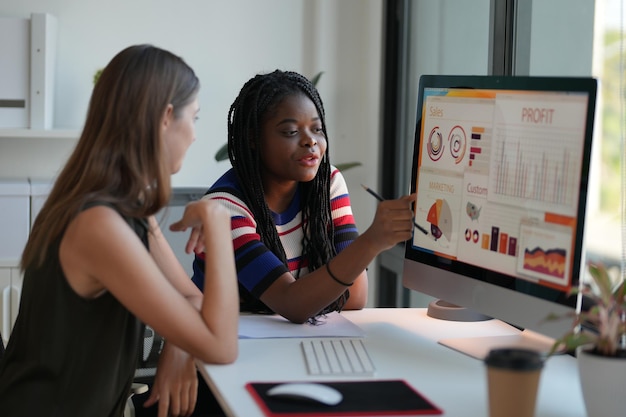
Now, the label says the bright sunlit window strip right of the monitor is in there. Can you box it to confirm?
[588,0,626,271]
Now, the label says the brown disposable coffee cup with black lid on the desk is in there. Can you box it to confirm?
[485,348,543,417]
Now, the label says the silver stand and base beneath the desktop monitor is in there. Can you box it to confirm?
[427,300,554,360]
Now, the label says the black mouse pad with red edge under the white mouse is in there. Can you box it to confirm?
[246,379,443,417]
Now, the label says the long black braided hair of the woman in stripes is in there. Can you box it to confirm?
[228,70,349,314]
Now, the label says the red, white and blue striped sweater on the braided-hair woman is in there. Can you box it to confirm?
[192,167,358,308]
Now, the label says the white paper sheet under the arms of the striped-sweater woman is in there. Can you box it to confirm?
[239,311,365,339]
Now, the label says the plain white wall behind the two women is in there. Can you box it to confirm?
[0,0,383,304]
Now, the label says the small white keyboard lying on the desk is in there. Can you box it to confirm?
[301,337,376,376]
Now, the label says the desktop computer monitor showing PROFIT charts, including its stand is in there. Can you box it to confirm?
[403,75,597,357]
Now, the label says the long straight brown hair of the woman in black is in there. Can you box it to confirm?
[21,45,200,270]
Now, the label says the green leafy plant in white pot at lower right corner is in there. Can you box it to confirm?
[551,263,626,417]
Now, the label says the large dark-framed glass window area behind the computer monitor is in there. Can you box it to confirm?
[378,0,626,306]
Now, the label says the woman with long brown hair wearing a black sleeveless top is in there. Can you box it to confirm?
[0,45,238,417]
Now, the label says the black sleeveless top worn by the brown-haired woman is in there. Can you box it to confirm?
[0,203,148,417]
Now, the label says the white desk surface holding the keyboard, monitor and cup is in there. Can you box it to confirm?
[199,308,585,417]
